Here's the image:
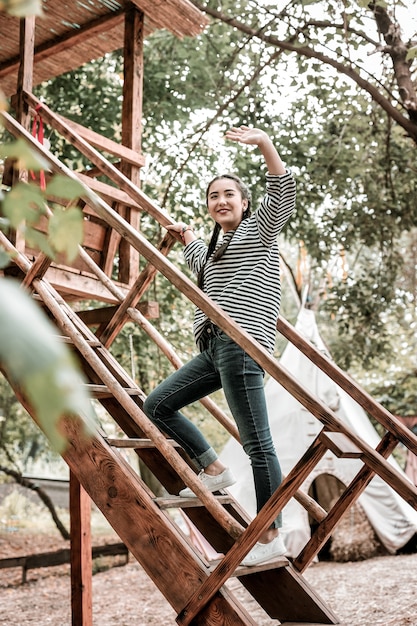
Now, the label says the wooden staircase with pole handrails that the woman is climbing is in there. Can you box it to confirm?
[0,105,417,626]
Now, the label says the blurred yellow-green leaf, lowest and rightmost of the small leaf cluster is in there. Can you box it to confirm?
[49,207,84,261]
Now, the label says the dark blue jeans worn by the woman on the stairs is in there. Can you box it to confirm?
[143,326,282,528]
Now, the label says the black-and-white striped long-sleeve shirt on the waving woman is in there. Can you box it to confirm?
[184,171,295,352]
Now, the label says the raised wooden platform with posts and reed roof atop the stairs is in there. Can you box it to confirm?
[0,0,207,304]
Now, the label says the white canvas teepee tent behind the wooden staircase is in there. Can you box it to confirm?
[221,308,417,556]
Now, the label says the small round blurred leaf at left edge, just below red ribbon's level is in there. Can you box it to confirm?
[3,183,45,228]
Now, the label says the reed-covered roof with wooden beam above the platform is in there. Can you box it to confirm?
[0,0,207,96]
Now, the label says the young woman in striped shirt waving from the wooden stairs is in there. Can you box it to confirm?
[144,126,295,565]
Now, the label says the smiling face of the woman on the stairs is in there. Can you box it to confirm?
[207,178,248,233]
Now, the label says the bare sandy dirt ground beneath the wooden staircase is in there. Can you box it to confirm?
[0,532,417,626]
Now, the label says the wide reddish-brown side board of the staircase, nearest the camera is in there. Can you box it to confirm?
[3,388,255,626]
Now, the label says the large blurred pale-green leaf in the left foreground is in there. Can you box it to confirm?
[0,279,95,451]
